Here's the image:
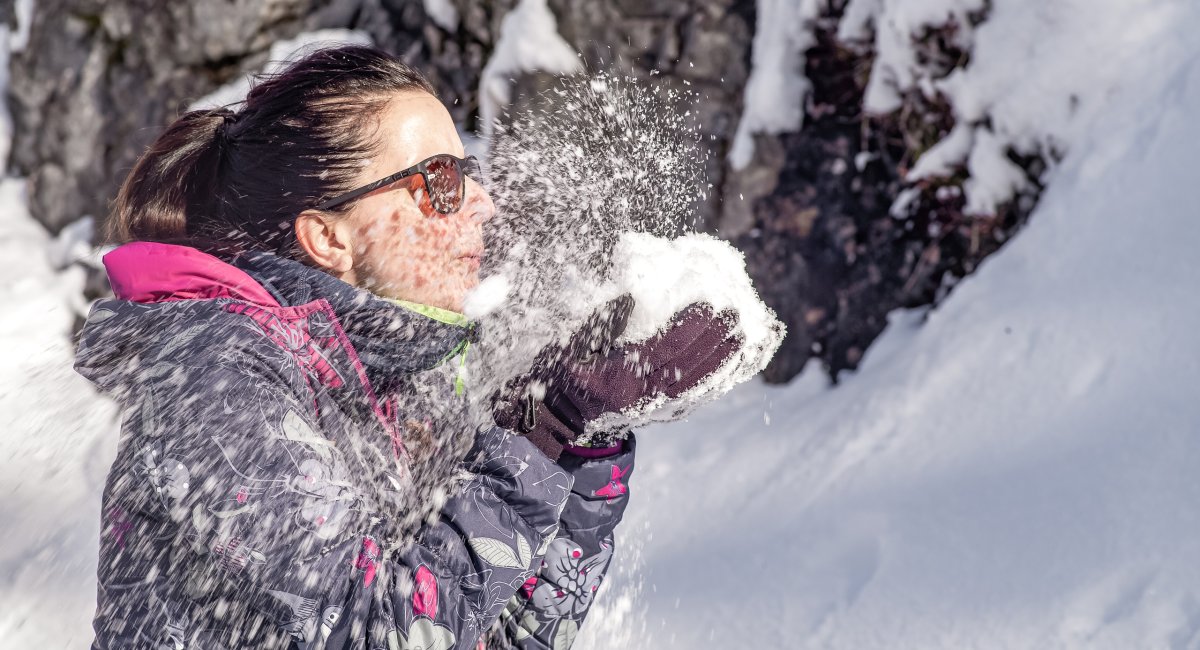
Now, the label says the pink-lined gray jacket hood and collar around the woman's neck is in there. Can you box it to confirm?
[77,242,474,392]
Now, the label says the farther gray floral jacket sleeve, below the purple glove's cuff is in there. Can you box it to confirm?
[487,435,636,650]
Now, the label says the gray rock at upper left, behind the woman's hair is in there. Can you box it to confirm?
[8,0,328,231]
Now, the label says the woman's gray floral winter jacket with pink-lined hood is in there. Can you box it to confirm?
[77,242,634,650]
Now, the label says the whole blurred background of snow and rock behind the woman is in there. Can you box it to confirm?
[0,0,1200,650]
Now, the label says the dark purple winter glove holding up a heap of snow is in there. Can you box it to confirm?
[493,295,740,459]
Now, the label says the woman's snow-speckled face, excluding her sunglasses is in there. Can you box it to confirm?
[344,91,496,312]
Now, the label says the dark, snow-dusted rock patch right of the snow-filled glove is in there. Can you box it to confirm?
[726,4,1043,383]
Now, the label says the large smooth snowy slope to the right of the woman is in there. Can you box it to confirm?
[582,1,1200,650]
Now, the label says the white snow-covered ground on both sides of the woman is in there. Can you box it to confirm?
[0,0,1200,650]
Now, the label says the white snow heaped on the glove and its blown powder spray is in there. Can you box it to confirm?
[467,73,784,441]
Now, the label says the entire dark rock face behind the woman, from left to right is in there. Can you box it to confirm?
[8,0,1042,381]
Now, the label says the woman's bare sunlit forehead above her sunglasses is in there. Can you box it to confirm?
[371,91,463,175]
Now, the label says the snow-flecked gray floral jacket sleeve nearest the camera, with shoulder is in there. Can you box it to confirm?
[92,366,571,650]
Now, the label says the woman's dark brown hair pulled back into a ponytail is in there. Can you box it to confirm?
[108,46,436,251]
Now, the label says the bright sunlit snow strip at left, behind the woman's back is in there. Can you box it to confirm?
[0,179,116,650]
